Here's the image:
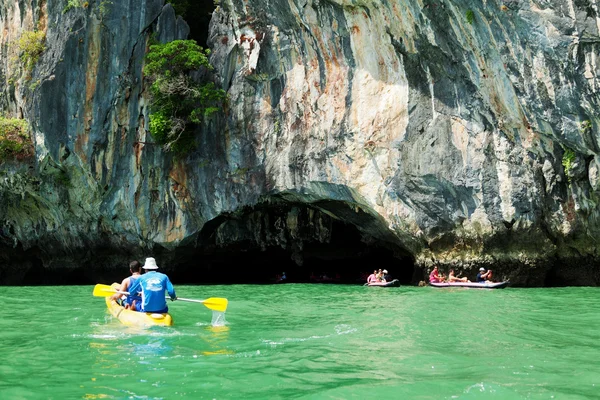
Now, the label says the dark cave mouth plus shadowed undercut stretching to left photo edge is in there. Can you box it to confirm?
[0,198,420,285]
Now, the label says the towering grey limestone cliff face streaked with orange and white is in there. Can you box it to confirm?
[0,0,600,286]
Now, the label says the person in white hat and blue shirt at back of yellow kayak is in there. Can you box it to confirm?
[129,257,177,314]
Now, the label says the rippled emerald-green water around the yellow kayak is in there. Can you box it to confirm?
[0,284,600,399]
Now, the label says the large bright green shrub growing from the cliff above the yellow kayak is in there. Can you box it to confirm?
[144,40,226,155]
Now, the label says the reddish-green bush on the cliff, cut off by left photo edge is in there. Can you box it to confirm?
[0,117,33,162]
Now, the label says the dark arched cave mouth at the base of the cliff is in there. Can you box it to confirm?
[169,202,415,284]
